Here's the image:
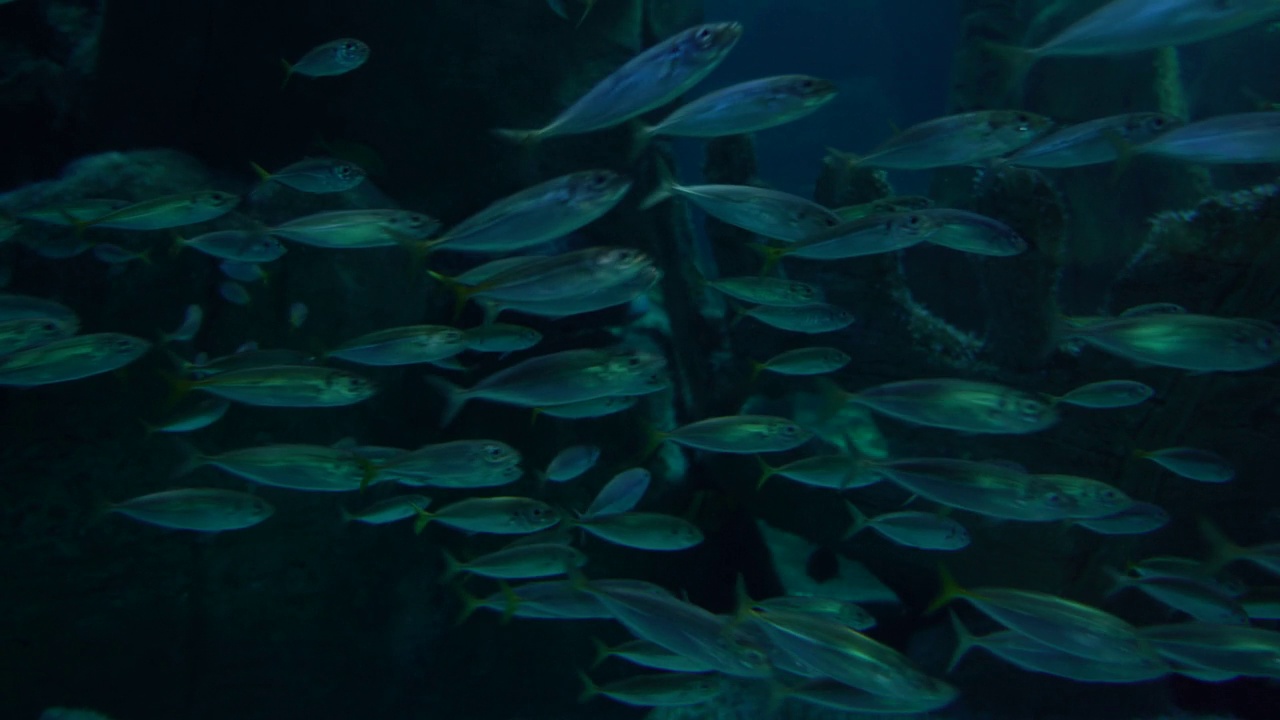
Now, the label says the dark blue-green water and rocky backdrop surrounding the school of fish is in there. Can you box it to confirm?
[0,0,1280,720]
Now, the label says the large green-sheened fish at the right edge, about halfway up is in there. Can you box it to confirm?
[1060,311,1280,373]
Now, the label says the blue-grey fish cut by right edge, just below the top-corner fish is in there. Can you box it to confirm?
[1134,111,1280,165]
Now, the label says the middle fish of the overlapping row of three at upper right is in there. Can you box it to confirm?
[996,113,1185,169]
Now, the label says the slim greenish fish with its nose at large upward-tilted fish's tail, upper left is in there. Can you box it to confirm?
[262,210,440,250]
